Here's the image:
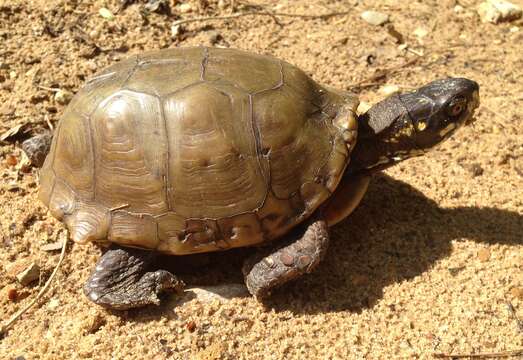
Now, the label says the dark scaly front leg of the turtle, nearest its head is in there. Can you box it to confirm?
[243,217,329,299]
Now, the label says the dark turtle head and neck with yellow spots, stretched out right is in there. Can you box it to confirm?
[352,78,479,174]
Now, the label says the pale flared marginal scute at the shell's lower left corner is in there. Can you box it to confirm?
[65,203,111,244]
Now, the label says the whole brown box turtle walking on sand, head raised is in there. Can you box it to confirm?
[35,47,479,310]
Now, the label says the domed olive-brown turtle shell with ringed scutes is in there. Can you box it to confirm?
[39,48,358,254]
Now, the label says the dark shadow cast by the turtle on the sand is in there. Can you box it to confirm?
[125,174,523,320]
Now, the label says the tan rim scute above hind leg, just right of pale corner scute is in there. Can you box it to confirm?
[108,211,159,249]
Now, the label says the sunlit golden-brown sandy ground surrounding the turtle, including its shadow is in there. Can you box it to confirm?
[0,0,523,359]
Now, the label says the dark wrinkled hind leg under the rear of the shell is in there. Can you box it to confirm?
[84,248,183,310]
